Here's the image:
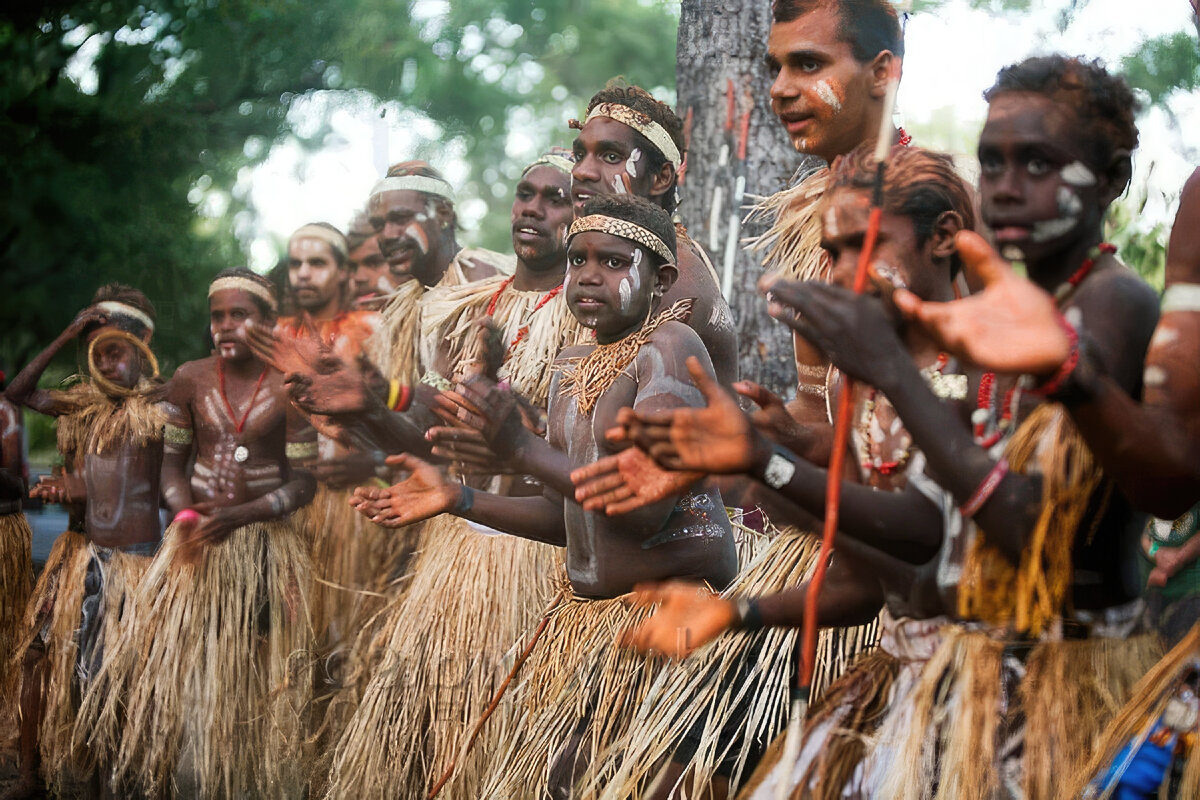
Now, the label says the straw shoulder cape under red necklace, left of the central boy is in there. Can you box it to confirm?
[421,275,592,408]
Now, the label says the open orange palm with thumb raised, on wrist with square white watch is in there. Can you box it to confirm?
[607,357,769,475]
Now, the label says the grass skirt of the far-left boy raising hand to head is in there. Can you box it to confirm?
[5,530,151,788]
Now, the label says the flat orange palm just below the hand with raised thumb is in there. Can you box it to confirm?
[571,447,704,517]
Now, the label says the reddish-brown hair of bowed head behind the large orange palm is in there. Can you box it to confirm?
[821,143,976,273]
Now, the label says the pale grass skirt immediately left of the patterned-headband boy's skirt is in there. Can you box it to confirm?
[325,515,563,800]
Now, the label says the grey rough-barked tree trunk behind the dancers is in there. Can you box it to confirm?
[676,0,820,397]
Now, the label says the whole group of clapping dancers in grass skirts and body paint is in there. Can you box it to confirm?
[0,0,1200,800]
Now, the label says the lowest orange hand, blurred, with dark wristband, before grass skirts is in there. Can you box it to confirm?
[619,581,738,658]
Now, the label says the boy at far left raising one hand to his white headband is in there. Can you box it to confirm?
[5,284,167,796]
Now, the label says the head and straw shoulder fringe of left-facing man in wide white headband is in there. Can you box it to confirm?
[367,161,512,385]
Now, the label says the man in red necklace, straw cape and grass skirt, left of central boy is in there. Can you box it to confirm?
[329,149,589,800]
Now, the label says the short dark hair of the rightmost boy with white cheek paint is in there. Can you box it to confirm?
[983,54,1140,183]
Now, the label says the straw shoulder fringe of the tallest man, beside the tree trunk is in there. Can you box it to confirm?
[743,167,829,281]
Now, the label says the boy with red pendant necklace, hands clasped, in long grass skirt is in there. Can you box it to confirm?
[80,269,316,798]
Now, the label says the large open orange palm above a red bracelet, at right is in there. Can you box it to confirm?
[893,230,1070,375]
